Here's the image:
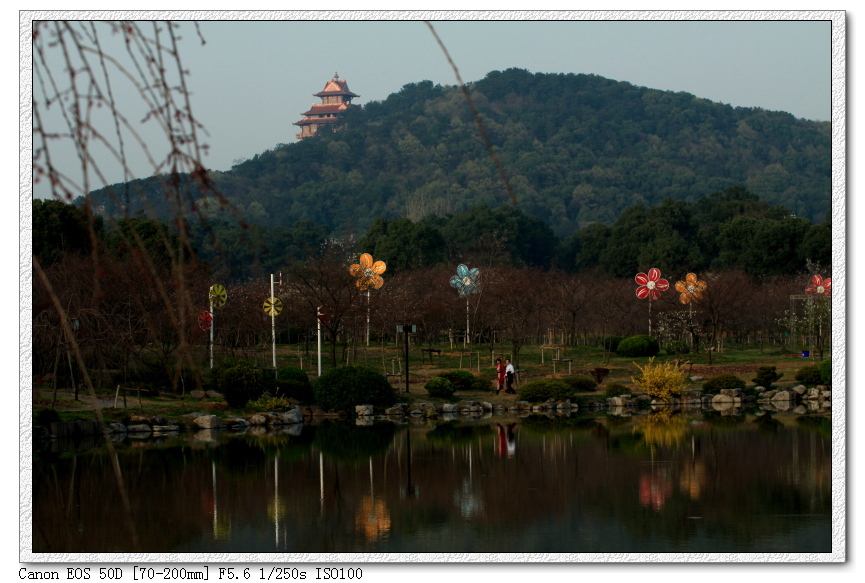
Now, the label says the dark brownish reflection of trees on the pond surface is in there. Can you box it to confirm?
[33,416,831,552]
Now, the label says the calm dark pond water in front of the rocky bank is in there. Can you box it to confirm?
[32,413,832,553]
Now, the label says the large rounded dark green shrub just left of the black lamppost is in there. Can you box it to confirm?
[314,365,399,411]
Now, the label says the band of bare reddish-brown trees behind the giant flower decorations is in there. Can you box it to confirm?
[33,193,831,388]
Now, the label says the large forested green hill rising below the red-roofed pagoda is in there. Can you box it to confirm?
[86,69,831,237]
